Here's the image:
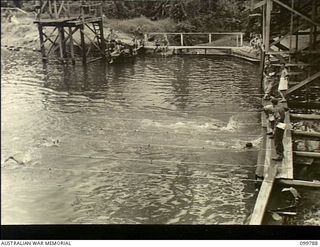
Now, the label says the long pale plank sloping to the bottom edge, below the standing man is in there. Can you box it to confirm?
[250,163,278,225]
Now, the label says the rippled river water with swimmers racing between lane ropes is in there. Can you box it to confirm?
[1,51,260,224]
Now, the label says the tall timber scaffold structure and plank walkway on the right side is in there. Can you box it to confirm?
[250,0,320,225]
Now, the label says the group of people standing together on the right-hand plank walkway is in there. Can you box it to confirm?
[263,55,288,161]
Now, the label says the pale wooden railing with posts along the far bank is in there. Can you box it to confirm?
[144,32,244,47]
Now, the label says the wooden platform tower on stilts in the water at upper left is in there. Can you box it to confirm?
[34,0,105,63]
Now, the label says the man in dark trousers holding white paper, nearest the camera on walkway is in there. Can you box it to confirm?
[271,98,288,161]
